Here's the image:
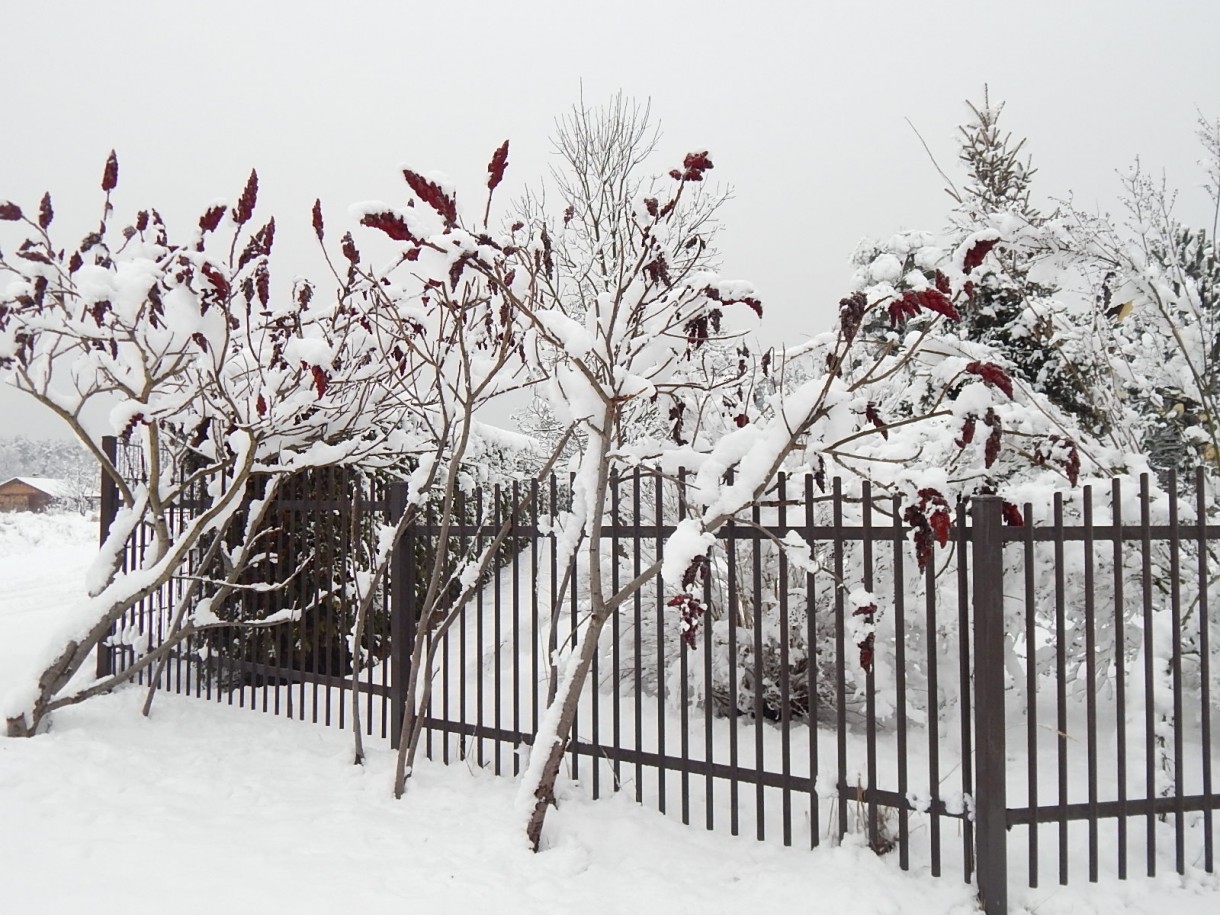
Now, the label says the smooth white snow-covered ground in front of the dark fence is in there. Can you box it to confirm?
[0,515,1220,915]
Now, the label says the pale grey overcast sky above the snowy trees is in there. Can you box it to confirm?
[0,0,1220,444]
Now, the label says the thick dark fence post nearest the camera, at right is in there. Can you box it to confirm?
[963,495,1008,915]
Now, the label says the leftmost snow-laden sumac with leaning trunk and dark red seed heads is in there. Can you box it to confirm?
[0,144,544,733]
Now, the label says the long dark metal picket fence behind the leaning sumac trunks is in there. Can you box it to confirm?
[99,441,1220,911]
